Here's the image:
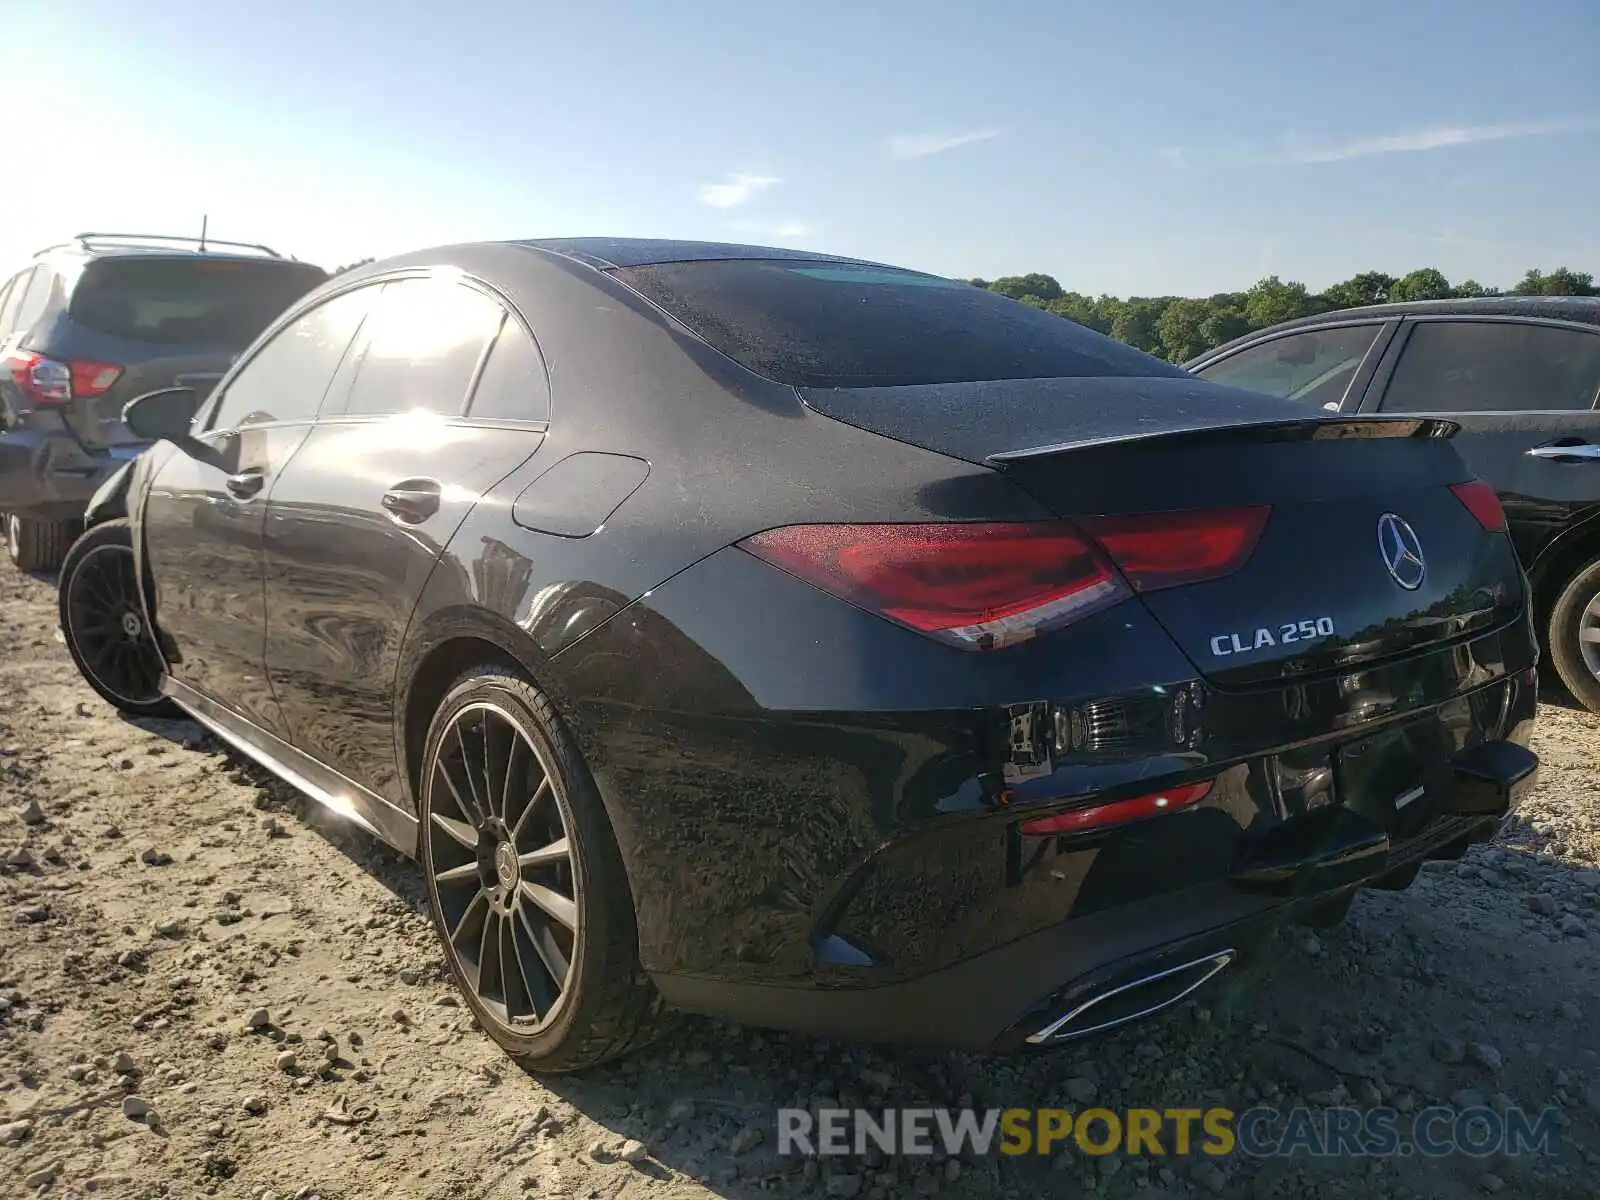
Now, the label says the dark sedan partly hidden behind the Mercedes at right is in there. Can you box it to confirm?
[1187,296,1600,712]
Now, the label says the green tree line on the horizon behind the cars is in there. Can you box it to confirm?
[968,267,1600,363]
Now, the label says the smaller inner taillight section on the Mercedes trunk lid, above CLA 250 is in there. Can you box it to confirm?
[1080,506,1272,592]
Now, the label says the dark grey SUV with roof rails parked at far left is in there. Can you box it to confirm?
[0,234,328,571]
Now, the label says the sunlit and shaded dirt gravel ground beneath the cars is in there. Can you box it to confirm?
[0,566,1600,1200]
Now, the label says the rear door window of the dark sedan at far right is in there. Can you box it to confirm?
[1382,322,1600,413]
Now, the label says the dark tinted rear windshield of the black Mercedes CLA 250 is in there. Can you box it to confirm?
[616,259,1184,387]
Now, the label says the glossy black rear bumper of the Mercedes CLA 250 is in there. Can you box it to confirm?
[552,552,1538,1048]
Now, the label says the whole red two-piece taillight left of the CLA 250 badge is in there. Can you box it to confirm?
[741,507,1270,650]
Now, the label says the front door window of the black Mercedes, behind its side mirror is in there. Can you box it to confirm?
[208,288,376,429]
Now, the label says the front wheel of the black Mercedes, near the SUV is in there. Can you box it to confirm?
[56,520,181,717]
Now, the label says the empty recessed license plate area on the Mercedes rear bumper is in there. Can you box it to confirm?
[1333,717,1451,842]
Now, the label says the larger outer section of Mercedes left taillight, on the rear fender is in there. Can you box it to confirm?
[741,522,1130,650]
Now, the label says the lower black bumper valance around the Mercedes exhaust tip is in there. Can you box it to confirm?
[654,742,1536,1053]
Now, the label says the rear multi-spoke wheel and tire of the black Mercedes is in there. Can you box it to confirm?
[421,666,659,1072]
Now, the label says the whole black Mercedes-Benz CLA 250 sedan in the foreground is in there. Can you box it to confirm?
[61,238,1536,1070]
